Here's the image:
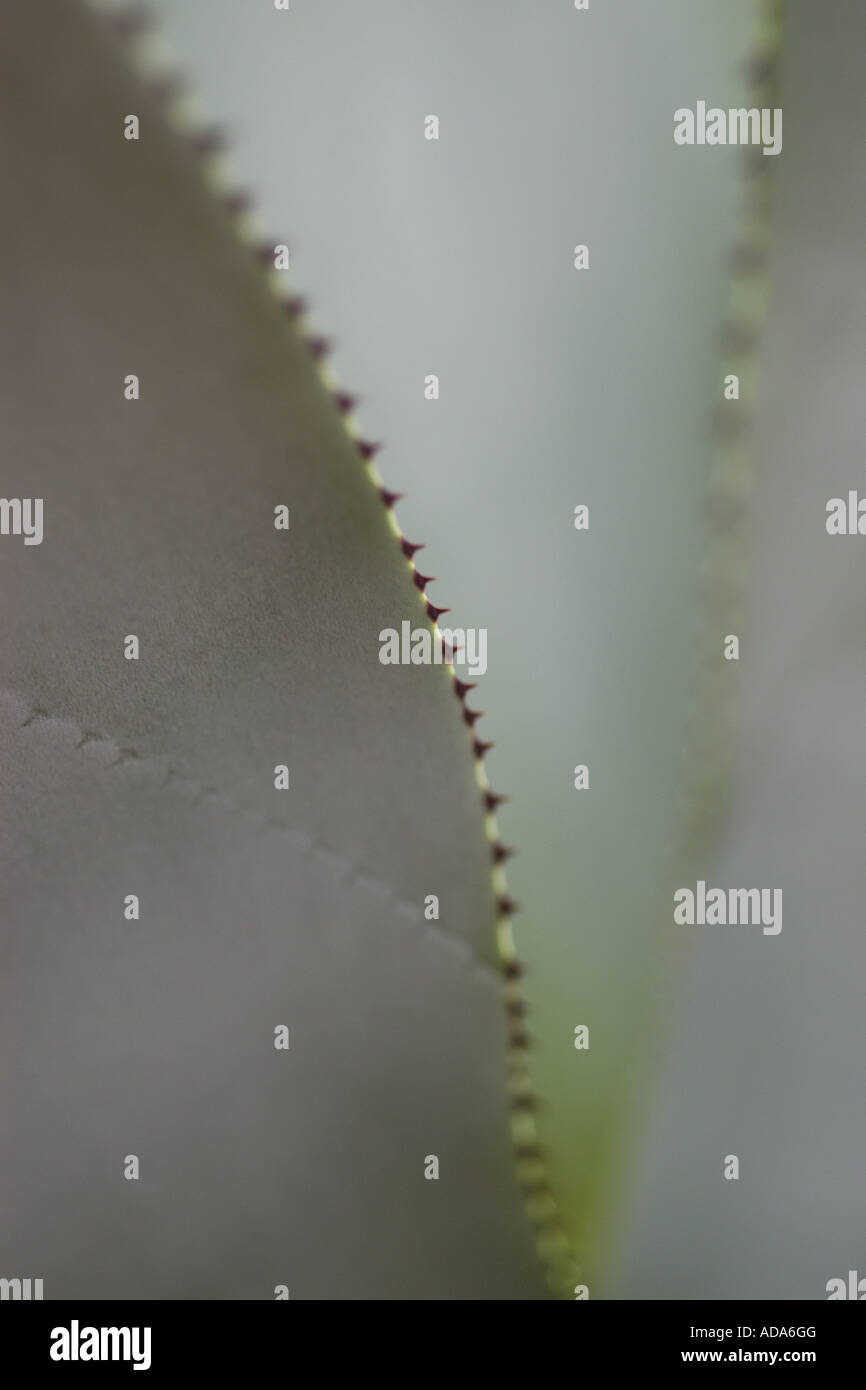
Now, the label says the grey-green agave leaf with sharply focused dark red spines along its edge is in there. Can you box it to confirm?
[0,0,544,1298]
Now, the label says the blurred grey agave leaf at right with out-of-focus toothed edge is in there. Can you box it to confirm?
[620,0,866,1300]
